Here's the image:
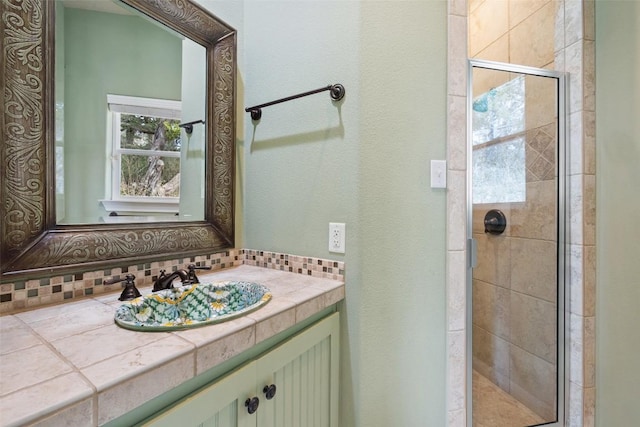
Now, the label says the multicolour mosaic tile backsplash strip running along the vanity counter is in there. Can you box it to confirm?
[0,249,344,314]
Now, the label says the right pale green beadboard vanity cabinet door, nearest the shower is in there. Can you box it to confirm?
[256,313,339,427]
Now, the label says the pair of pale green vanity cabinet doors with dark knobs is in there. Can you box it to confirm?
[143,313,339,427]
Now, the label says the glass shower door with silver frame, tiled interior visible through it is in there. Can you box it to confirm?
[467,60,566,427]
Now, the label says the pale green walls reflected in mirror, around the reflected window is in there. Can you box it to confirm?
[55,1,206,224]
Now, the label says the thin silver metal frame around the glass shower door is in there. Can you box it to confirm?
[465,59,570,427]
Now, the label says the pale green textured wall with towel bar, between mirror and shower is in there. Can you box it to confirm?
[240,1,446,427]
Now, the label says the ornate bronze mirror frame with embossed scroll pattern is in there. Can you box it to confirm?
[0,0,237,283]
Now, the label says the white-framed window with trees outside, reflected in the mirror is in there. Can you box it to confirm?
[100,94,182,222]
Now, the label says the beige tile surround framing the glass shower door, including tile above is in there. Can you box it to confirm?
[447,0,596,427]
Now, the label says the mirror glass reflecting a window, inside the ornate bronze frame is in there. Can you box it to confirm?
[55,0,206,224]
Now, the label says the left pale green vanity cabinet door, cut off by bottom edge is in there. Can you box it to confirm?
[142,362,263,427]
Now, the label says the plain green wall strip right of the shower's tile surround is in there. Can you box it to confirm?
[595,1,640,426]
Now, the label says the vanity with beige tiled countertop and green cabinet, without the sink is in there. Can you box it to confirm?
[0,265,344,426]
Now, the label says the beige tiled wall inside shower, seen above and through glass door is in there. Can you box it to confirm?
[469,0,558,420]
